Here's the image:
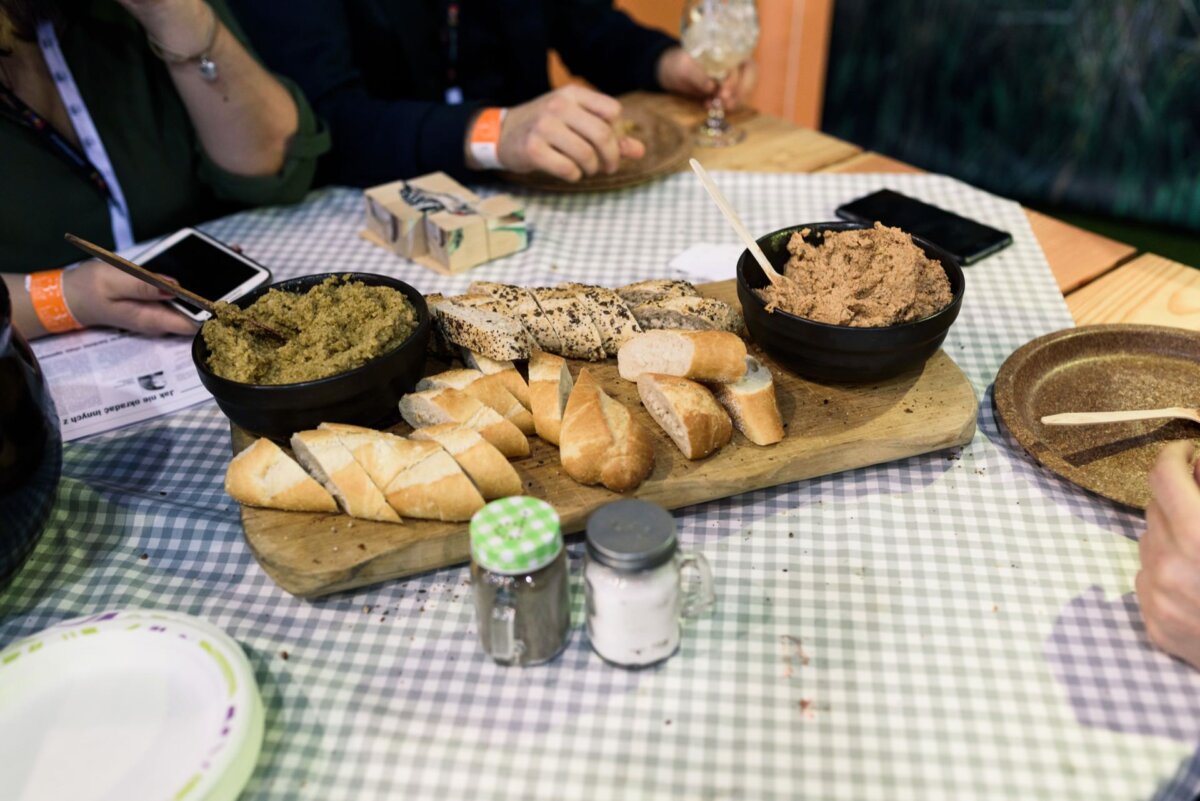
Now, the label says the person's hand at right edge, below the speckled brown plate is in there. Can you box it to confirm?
[1136,442,1200,668]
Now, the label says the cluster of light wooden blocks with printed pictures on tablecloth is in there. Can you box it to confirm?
[364,173,529,275]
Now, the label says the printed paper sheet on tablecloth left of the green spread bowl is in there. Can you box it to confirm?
[30,329,212,441]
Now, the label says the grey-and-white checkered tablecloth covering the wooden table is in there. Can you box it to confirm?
[0,173,1200,801]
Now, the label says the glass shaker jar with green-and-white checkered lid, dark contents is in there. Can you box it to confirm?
[470,496,571,666]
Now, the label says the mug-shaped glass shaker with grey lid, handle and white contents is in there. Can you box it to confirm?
[583,500,716,668]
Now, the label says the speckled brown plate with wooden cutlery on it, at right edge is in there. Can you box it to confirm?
[992,325,1200,508]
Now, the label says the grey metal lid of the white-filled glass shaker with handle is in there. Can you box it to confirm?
[587,500,678,572]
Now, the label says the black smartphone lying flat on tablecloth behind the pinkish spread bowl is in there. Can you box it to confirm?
[838,189,1013,265]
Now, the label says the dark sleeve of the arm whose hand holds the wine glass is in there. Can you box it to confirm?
[544,0,678,95]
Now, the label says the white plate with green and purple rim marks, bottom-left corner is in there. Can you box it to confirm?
[0,610,263,801]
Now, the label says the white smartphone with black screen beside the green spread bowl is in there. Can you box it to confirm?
[134,228,271,323]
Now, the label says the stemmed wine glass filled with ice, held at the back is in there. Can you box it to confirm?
[679,0,758,147]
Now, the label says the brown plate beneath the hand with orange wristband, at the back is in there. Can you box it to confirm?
[503,96,691,192]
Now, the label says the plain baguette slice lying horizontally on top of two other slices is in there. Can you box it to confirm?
[617,331,746,381]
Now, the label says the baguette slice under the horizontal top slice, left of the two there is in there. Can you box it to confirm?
[637,373,733,459]
